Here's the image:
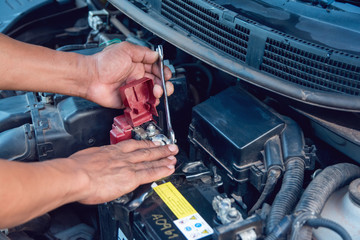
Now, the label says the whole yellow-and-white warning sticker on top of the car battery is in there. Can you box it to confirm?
[152,182,214,240]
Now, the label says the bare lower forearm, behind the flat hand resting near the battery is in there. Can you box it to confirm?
[0,159,87,229]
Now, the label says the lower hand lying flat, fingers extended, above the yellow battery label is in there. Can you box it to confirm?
[69,140,178,204]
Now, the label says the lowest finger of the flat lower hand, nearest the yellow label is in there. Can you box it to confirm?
[135,167,175,185]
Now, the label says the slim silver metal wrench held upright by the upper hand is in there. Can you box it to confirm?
[156,45,176,144]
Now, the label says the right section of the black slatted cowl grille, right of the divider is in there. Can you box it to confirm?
[261,38,360,96]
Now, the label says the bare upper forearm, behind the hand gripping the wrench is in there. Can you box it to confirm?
[0,34,95,97]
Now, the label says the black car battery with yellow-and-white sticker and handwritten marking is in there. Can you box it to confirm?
[99,175,219,240]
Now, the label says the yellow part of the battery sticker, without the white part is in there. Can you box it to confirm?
[153,182,197,219]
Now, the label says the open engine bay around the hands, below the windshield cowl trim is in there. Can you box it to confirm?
[0,1,360,240]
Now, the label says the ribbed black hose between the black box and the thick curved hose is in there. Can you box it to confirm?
[266,157,305,234]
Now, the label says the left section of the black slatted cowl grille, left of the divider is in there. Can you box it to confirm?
[161,0,250,62]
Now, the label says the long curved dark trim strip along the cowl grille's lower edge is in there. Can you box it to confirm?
[109,0,360,112]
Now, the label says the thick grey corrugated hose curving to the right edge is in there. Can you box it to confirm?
[291,163,360,239]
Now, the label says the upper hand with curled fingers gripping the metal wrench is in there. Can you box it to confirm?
[85,42,174,108]
